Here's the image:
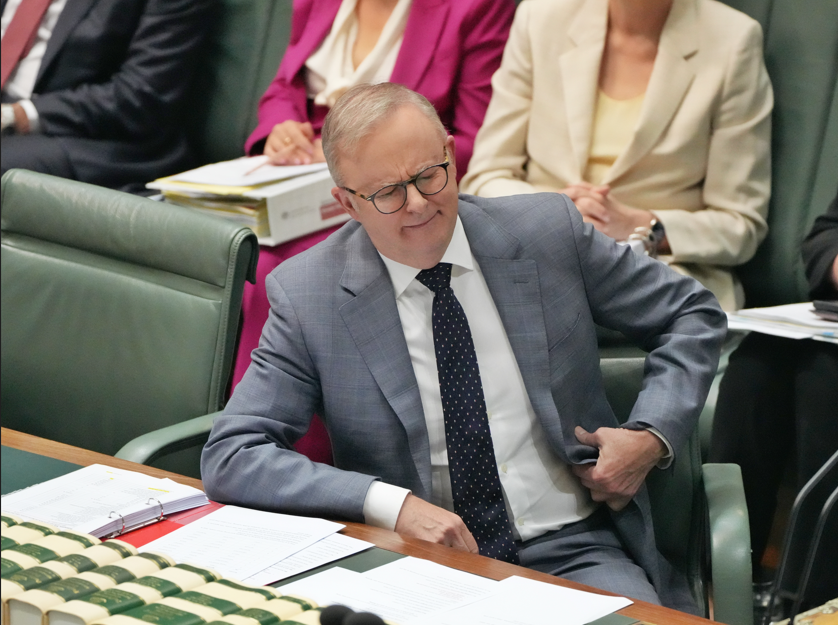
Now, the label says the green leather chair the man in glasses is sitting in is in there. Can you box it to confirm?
[600,357,753,625]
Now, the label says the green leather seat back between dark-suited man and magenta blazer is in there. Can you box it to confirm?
[187,0,292,164]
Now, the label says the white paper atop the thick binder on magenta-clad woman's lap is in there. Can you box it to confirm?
[170,156,327,187]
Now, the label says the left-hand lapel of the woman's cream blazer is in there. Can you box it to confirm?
[559,0,608,180]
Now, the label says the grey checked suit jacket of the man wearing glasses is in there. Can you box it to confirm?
[202,193,725,605]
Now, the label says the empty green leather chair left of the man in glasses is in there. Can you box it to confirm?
[0,170,258,477]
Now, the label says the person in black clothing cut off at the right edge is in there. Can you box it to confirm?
[709,188,838,605]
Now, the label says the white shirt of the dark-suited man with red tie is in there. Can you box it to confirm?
[0,0,67,132]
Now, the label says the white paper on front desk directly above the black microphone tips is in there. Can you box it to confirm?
[281,557,498,625]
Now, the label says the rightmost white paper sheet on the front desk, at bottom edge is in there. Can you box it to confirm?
[420,576,632,625]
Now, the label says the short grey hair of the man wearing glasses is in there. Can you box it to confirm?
[322,82,448,186]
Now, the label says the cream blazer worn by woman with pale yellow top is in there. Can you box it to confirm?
[462,0,773,310]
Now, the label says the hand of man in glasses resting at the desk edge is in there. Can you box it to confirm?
[396,494,480,553]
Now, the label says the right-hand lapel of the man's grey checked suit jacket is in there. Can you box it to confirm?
[460,202,567,462]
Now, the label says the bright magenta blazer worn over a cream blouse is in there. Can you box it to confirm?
[245,0,515,177]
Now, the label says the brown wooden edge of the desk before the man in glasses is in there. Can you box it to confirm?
[0,428,710,625]
